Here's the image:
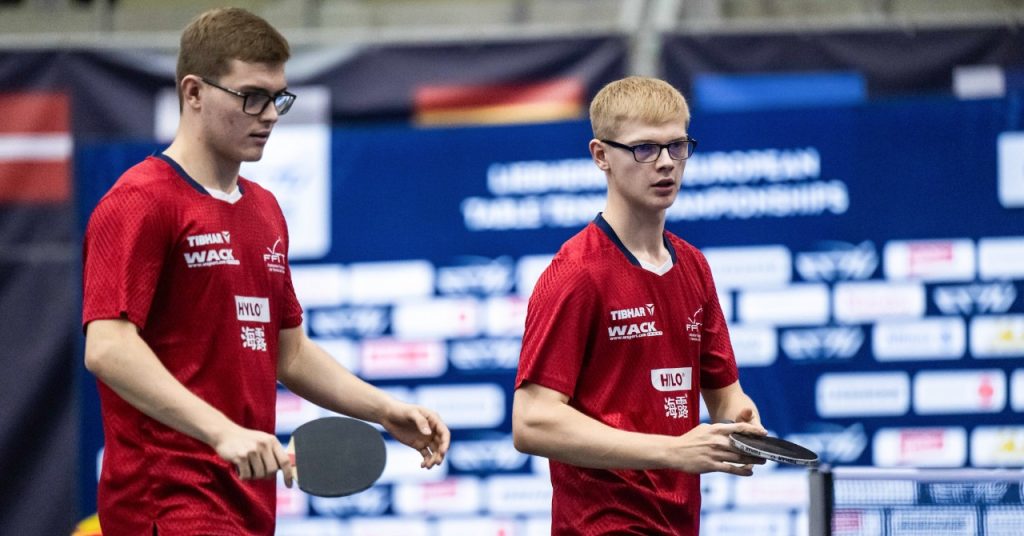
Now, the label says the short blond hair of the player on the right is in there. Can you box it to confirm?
[590,76,690,139]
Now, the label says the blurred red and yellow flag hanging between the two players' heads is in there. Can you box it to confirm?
[414,78,585,125]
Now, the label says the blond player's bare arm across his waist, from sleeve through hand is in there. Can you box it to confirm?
[512,383,764,476]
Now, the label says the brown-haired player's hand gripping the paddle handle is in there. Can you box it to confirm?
[213,426,294,488]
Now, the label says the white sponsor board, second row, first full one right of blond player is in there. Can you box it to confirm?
[736,283,828,326]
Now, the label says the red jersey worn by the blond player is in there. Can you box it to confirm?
[516,215,738,536]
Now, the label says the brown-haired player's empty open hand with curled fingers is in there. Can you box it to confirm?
[381,401,452,469]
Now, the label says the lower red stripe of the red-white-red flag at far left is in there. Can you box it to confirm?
[0,160,71,203]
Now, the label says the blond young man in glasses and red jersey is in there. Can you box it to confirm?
[512,77,766,536]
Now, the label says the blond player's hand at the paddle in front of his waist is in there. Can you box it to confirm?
[669,422,765,477]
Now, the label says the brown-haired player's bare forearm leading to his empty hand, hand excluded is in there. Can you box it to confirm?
[278,337,392,422]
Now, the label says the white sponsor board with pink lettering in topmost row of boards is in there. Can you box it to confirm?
[882,239,975,282]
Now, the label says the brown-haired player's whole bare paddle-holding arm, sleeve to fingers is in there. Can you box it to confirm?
[85,320,291,485]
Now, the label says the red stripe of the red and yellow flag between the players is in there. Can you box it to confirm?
[415,78,584,112]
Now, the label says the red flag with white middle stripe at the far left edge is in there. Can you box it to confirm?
[0,92,72,204]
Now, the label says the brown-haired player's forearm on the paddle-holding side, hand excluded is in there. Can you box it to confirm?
[85,321,236,446]
